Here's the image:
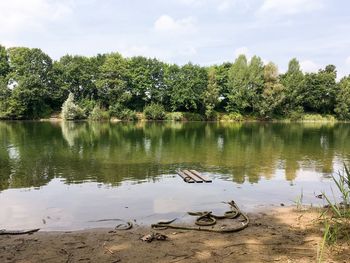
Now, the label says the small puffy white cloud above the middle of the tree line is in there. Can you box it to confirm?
[154,15,196,33]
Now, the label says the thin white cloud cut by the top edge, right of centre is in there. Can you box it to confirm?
[258,0,323,15]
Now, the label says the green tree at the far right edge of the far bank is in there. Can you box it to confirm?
[335,75,350,120]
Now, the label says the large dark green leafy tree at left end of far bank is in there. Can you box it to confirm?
[7,47,55,119]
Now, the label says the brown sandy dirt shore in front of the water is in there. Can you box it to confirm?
[0,207,350,263]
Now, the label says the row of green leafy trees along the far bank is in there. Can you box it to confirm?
[0,45,350,120]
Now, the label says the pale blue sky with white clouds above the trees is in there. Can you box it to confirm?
[0,0,350,77]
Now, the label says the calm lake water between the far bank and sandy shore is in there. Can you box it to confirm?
[0,122,350,230]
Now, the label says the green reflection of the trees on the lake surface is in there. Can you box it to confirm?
[0,122,350,190]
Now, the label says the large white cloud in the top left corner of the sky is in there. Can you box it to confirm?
[0,0,72,36]
